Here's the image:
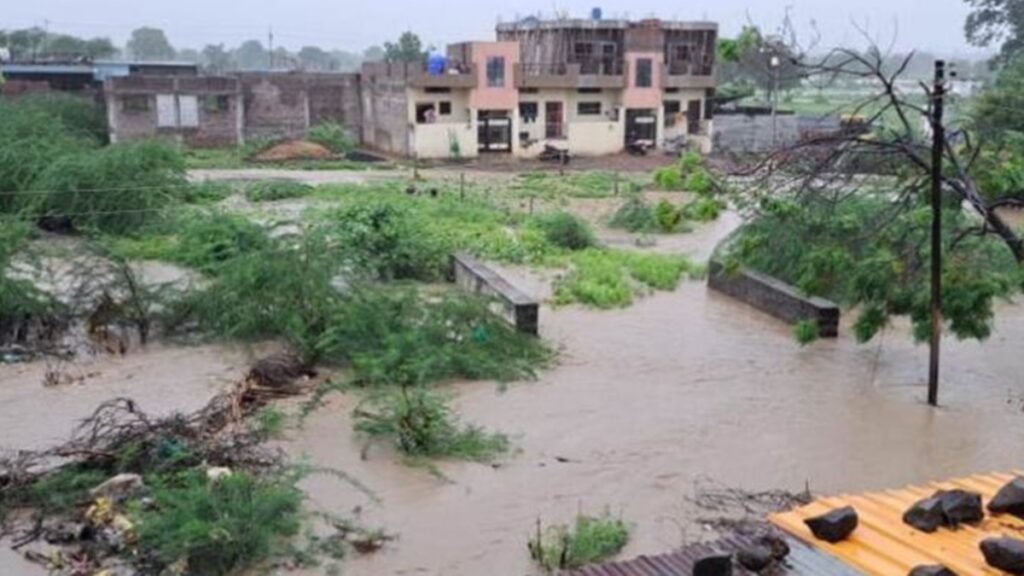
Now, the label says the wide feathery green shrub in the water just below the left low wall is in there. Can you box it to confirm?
[318,288,551,385]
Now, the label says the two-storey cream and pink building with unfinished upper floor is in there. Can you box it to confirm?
[361,18,718,158]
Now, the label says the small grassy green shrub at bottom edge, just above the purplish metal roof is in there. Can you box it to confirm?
[528,511,630,572]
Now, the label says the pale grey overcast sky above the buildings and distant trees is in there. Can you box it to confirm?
[0,0,977,54]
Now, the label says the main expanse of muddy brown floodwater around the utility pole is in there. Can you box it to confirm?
[289,215,1024,576]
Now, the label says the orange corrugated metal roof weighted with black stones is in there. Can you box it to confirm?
[769,471,1024,576]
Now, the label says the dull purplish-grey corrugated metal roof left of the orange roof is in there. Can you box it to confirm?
[569,535,859,576]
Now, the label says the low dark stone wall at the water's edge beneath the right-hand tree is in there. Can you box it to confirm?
[708,260,840,338]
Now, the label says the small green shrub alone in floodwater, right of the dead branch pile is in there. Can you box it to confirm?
[355,386,509,461]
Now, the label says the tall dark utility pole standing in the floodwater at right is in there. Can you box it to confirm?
[928,60,946,406]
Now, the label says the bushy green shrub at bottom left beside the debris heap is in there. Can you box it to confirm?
[133,471,302,576]
